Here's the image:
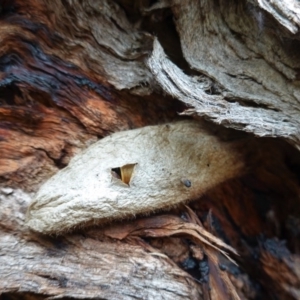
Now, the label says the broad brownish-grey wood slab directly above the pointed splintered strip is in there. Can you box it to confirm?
[168,0,300,105]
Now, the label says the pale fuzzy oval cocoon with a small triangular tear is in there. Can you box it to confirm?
[27,120,243,234]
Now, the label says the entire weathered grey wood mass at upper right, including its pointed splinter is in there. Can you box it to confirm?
[148,0,300,147]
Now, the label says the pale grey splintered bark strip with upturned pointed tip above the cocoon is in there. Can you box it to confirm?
[147,40,300,147]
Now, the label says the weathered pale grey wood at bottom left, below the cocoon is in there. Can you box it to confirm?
[0,189,201,300]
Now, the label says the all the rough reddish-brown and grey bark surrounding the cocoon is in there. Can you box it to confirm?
[0,0,300,299]
